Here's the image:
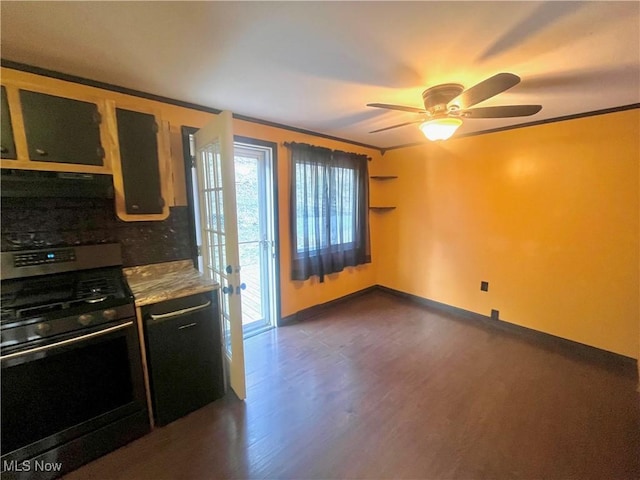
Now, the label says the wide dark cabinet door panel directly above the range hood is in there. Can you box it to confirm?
[20,90,104,166]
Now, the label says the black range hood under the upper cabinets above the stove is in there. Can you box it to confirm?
[0,168,114,198]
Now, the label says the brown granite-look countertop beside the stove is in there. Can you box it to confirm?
[124,260,219,307]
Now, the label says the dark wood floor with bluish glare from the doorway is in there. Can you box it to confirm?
[68,292,640,480]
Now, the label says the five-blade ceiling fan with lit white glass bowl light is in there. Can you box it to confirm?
[367,73,542,140]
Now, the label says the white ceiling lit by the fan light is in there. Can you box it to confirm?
[0,1,640,148]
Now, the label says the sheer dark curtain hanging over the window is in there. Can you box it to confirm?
[289,143,371,282]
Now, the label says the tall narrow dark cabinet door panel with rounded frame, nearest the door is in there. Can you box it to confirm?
[116,108,164,214]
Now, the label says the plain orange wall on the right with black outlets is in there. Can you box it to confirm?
[377,109,640,358]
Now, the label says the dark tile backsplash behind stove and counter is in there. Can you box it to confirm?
[1,198,191,267]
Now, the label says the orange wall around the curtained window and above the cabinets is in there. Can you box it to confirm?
[2,68,380,316]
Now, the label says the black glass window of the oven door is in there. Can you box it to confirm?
[2,334,135,453]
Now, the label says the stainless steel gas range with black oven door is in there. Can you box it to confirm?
[0,244,150,479]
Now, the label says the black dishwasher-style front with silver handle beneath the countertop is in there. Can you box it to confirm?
[142,291,224,426]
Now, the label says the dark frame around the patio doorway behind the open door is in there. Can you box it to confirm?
[181,126,282,327]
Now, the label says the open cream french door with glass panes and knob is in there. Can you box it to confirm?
[195,111,246,399]
